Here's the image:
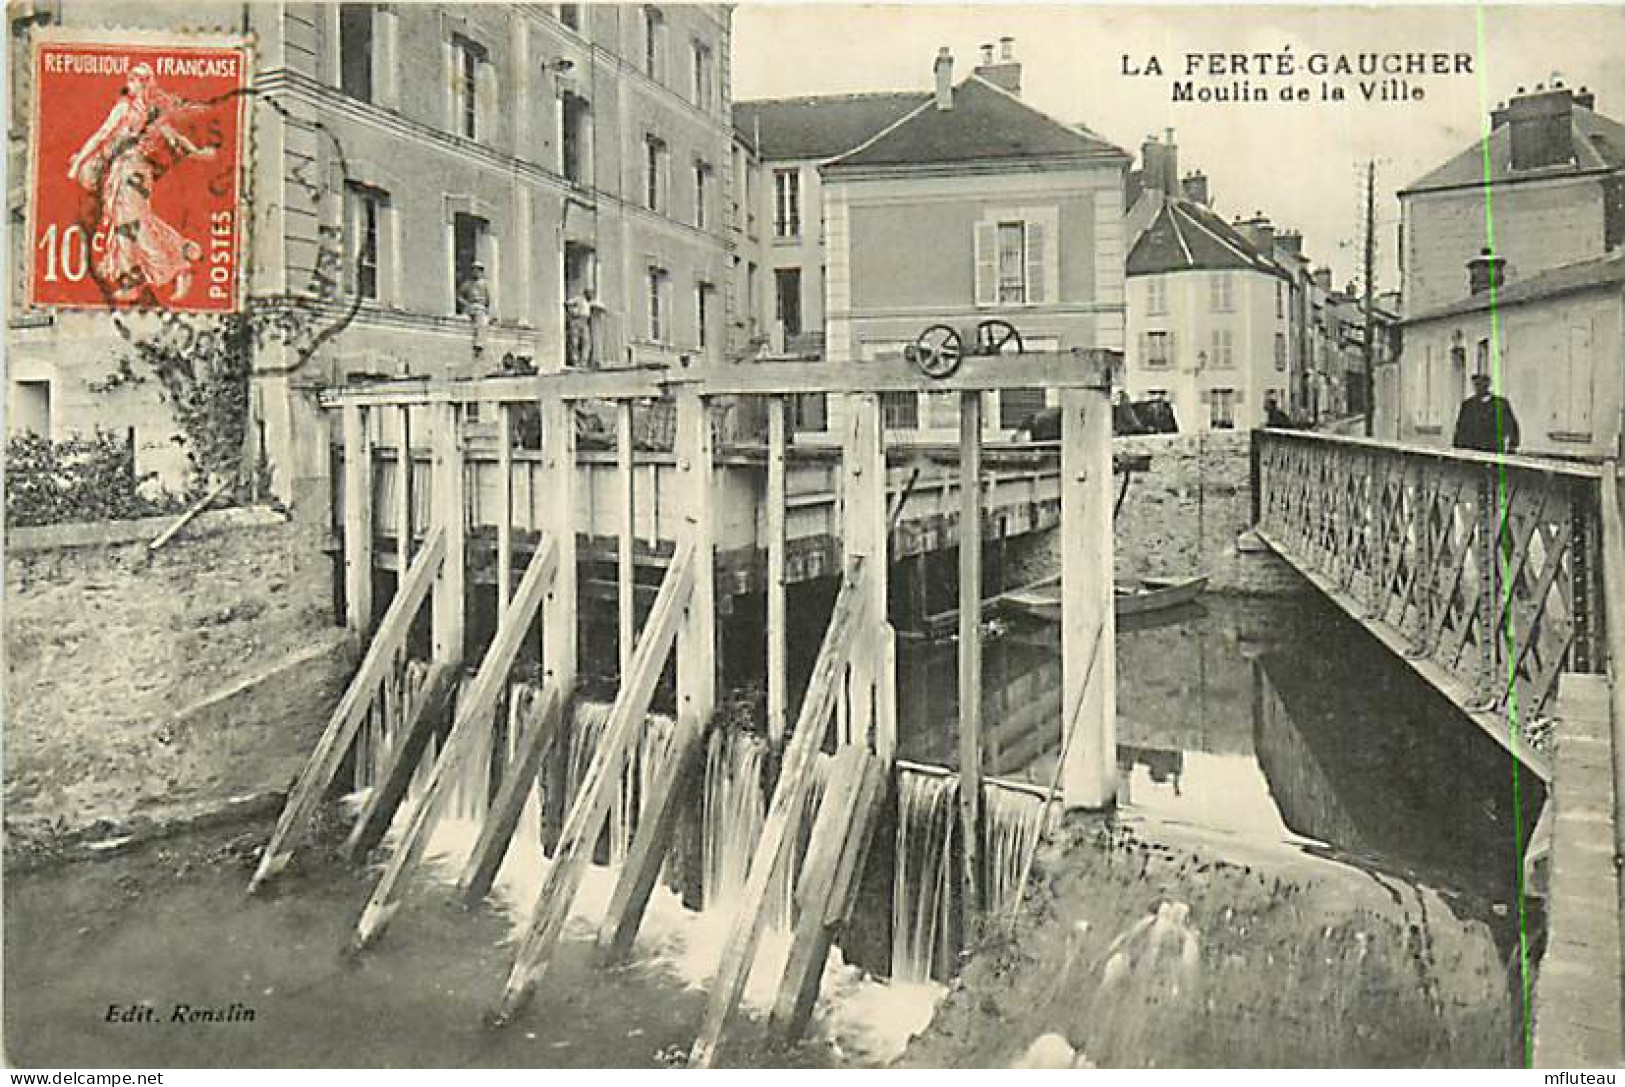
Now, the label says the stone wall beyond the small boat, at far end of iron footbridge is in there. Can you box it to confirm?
[1112,431,1305,593]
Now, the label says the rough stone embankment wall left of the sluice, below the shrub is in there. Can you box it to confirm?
[5,523,353,860]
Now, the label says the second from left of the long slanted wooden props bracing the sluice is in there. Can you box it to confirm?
[353,533,559,951]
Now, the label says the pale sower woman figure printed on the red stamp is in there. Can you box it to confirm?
[68,63,215,302]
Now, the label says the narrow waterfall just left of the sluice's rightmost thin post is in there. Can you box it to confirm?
[892,772,959,981]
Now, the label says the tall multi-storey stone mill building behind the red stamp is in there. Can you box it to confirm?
[11,2,746,499]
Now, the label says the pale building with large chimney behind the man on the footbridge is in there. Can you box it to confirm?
[1378,84,1625,457]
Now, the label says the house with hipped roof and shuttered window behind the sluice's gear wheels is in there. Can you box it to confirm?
[821,41,1129,432]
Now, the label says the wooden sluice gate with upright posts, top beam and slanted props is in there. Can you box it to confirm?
[250,351,1116,1066]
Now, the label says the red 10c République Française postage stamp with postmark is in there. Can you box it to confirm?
[28,37,249,314]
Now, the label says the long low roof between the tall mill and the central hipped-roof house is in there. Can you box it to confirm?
[733,91,930,159]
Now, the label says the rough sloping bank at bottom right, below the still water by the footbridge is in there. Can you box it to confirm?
[904,819,1513,1068]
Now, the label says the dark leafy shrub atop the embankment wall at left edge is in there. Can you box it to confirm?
[5,431,180,528]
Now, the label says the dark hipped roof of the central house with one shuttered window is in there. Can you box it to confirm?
[829,75,1129,169]
